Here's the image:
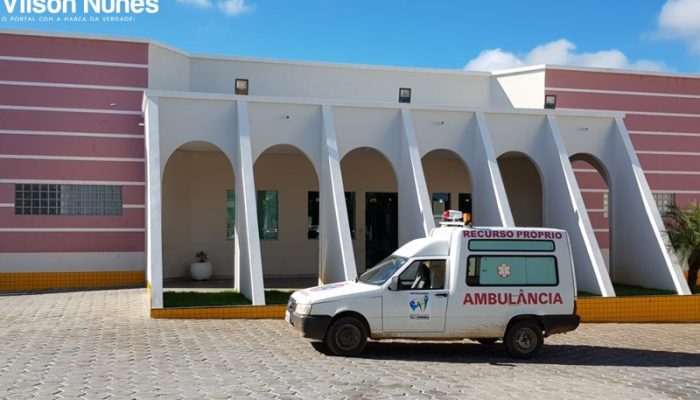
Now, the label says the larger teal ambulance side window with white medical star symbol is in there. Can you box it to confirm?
[467,255,559,286]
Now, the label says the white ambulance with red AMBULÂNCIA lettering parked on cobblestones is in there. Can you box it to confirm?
[286,211,579,358]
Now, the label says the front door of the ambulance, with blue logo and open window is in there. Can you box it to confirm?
[382,258,448,334]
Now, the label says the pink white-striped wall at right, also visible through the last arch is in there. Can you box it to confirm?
[545,68,700,248]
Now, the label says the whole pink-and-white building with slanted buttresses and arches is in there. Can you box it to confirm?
[0,31,688,308]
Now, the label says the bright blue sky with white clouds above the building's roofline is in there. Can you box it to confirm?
[0,0,700,73]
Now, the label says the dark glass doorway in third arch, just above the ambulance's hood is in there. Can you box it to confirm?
[365,192,399,269]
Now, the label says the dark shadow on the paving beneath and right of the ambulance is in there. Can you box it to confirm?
[312,341,700,367]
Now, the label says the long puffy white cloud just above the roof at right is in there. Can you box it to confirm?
[464,39,668,71]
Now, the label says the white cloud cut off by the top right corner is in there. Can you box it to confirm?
[657,0,700,52]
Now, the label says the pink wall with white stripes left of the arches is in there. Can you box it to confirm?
[0,34,148,252]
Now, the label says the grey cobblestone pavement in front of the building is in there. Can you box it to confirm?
[0,289,700,400]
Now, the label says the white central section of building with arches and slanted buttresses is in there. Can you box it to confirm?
[144,44,688,308]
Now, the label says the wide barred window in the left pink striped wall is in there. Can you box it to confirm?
[15,183,123,216]
